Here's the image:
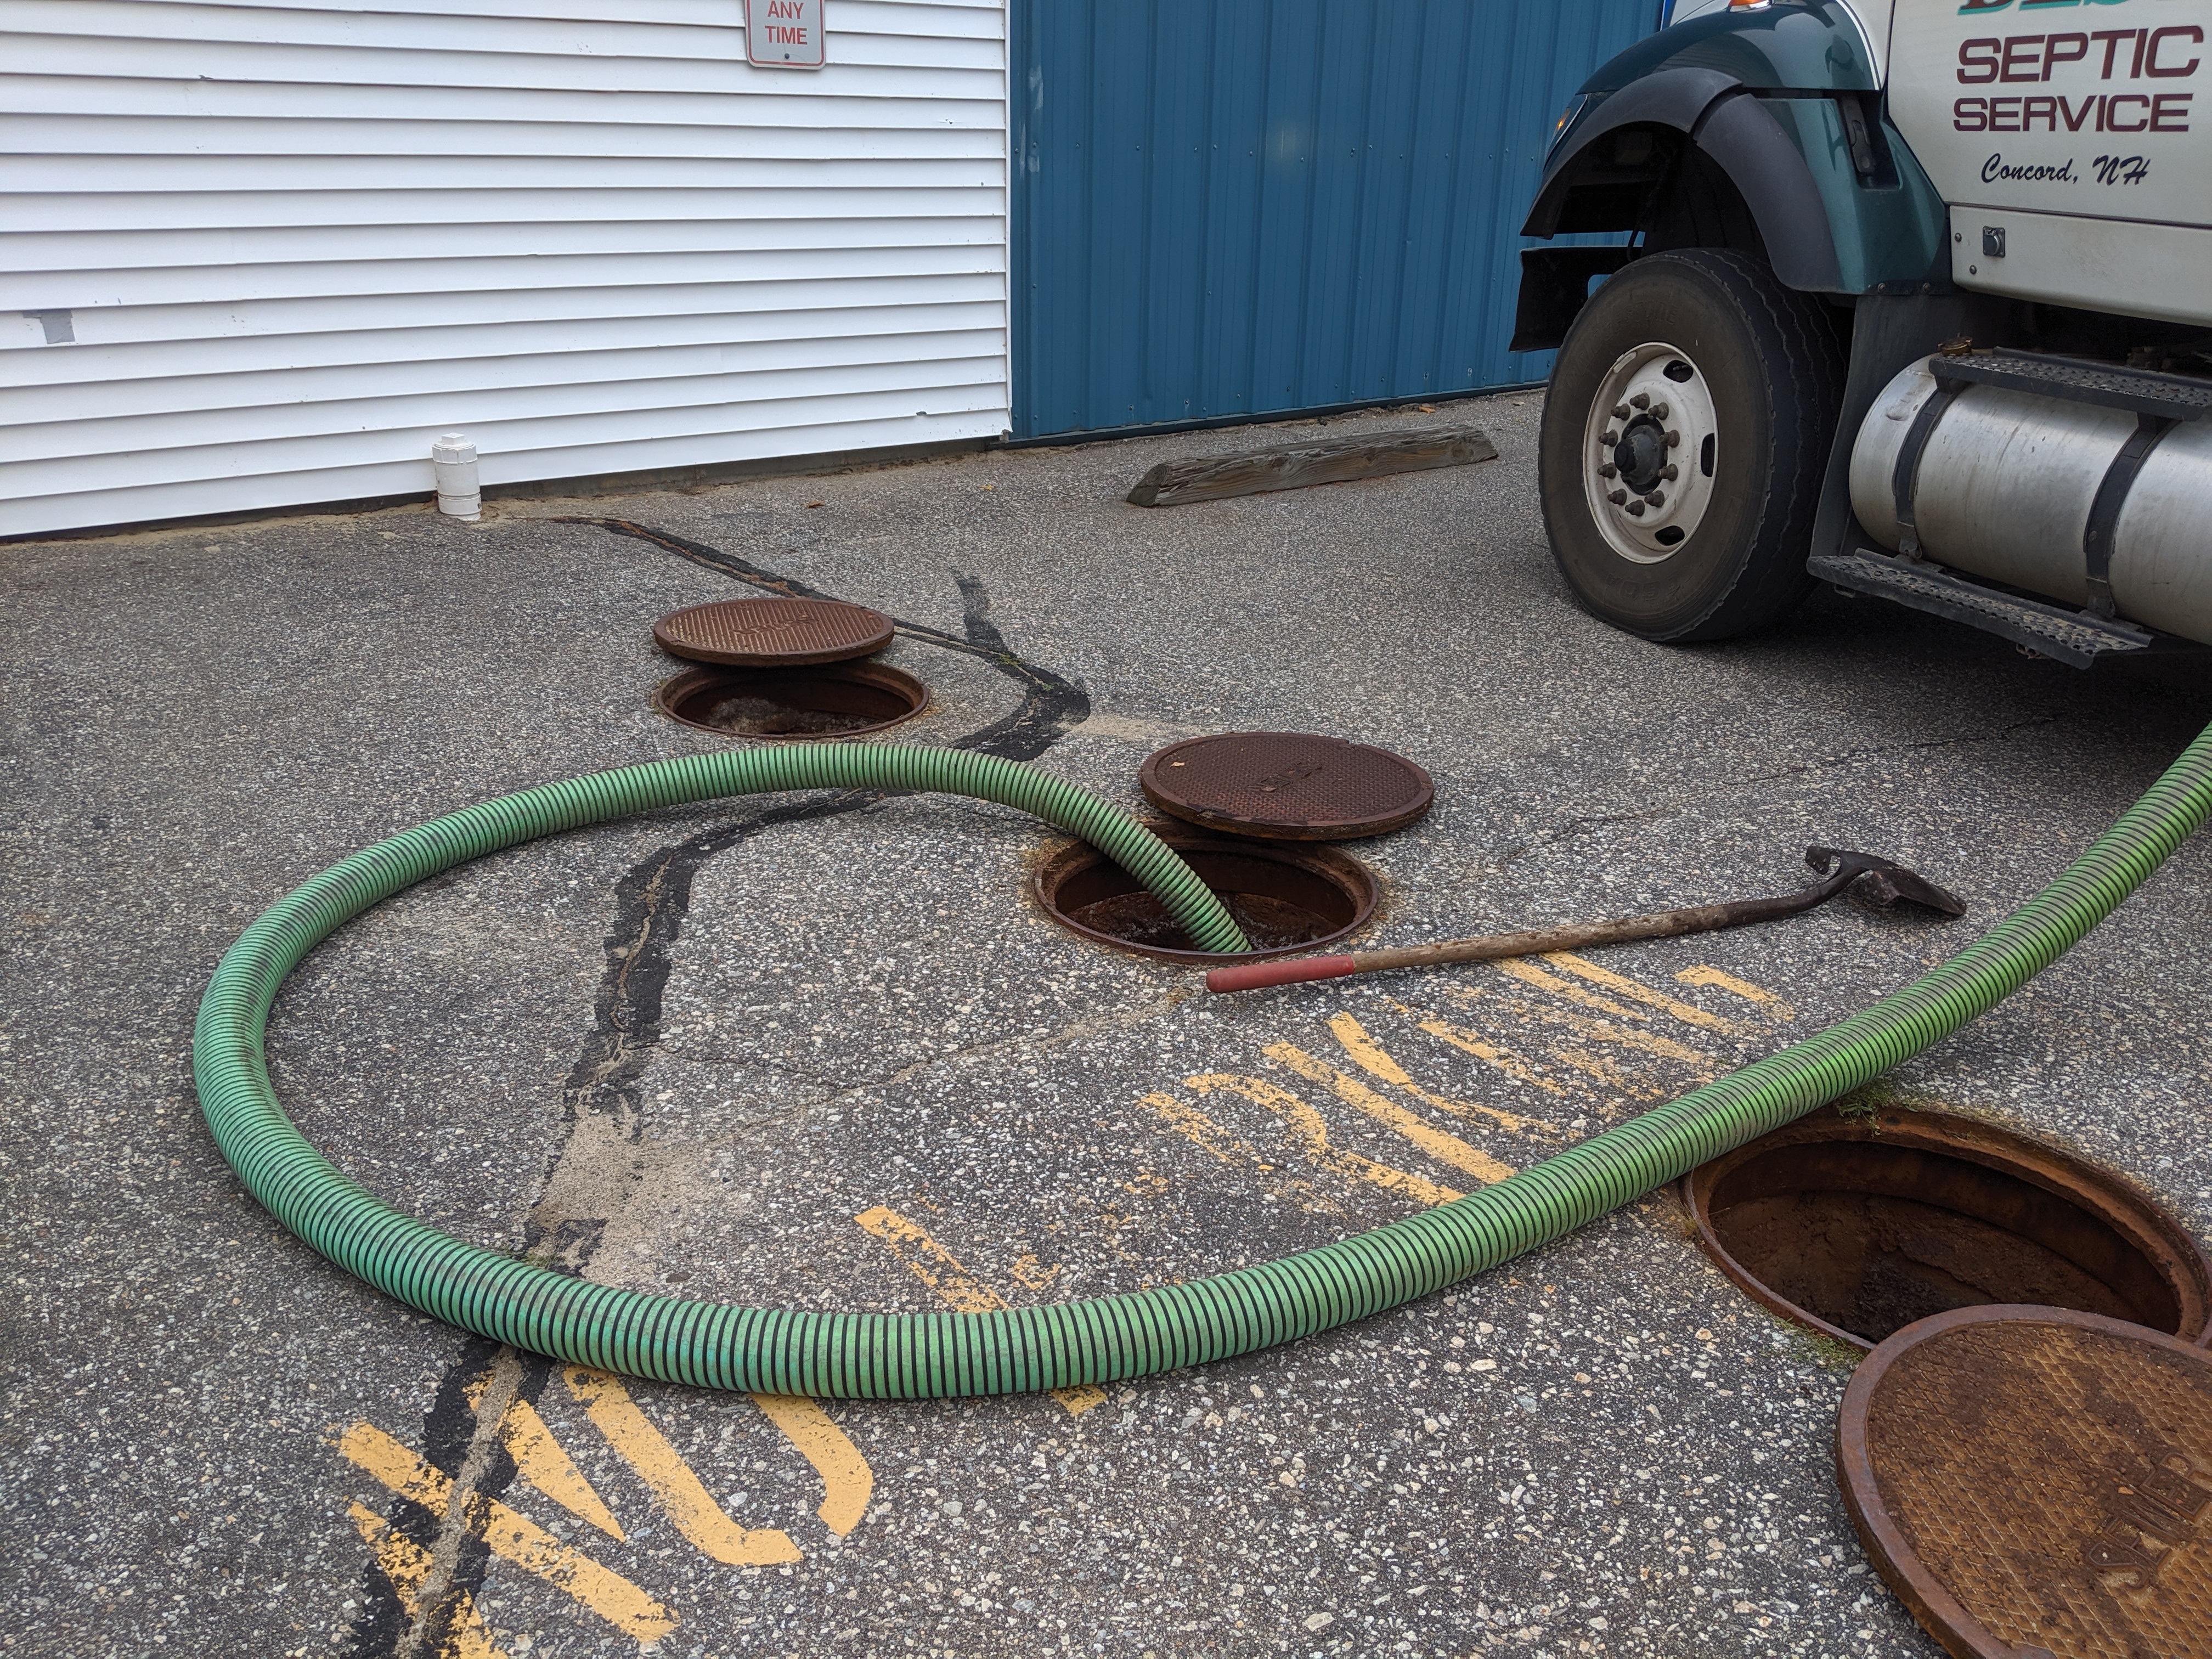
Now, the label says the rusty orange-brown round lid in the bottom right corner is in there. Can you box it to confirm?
[1836,1303,2212,1659]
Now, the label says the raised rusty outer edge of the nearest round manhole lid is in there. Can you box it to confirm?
[1834,1303,2208,1659]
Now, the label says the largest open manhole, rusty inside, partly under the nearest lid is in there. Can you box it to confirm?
[1683,1108,2212,1350]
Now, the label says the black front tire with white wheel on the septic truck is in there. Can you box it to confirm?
[1537,248,1845,644]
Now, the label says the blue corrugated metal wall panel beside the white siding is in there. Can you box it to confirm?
[1011,0,1659,438]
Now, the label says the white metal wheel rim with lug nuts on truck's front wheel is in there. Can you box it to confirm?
[1579,341,1721,564]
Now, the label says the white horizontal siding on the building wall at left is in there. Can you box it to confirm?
[0,0,1009,535]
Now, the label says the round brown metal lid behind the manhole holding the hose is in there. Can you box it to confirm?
[1137,732,1436,840]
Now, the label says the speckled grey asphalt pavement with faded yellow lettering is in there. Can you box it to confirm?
[0,394,2212,1659]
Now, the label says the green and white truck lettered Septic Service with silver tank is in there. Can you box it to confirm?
[1513,0,2212,668]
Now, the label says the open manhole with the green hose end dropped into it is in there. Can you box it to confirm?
[1035,825,1380,962]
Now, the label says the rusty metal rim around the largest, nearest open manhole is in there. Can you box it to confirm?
[1674,1106,2212,1354]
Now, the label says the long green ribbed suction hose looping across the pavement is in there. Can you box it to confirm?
[193,728,2212,1400]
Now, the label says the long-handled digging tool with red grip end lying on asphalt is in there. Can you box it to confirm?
[1205,847,1966,991]
